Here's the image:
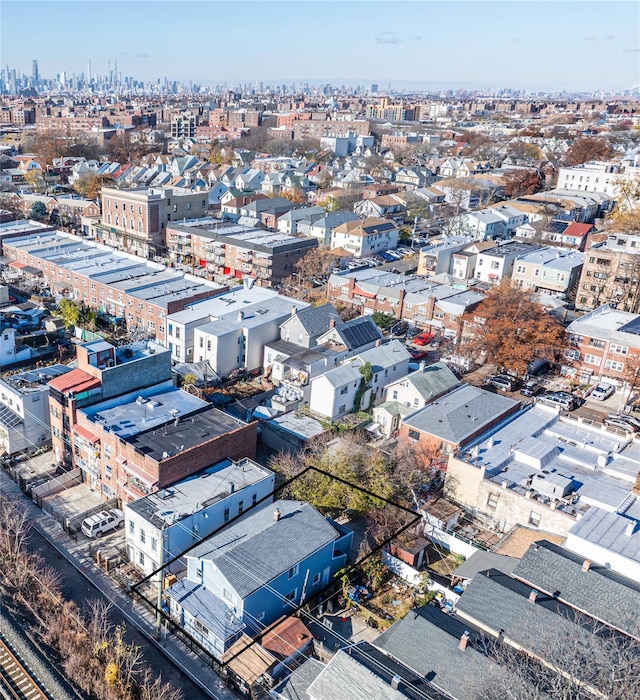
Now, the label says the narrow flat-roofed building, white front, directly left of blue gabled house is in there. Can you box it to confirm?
[124,457,275,575]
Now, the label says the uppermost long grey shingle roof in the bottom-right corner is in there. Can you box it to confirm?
[514,540,640,635]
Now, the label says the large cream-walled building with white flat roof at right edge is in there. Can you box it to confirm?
[442,403,640,536]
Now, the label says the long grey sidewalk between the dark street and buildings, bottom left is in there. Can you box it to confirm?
[0,471,237,700]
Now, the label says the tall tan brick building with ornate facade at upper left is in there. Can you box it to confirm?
[99,187,209,258]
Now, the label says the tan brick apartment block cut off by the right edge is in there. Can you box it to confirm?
[576,233,640,312]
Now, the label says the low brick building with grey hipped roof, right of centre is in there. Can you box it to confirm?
[400,384,520,454]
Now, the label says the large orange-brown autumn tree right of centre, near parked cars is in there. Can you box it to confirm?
[463,279,565,374]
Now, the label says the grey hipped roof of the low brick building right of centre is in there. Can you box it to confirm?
[404,384,518,445]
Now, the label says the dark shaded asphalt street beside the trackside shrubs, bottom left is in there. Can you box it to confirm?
[23,529,211,700]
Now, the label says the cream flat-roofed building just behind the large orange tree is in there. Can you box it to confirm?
[511,248,585,299]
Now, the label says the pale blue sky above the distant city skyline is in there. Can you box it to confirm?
[0,0,640,91]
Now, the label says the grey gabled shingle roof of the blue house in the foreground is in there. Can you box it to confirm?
[190,500,339,598]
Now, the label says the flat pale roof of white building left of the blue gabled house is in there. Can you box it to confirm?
[128,457,273,527]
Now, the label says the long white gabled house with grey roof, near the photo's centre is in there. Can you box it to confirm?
[309,340,411,420]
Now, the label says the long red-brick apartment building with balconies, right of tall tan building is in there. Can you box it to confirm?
[167,219,318,287]
